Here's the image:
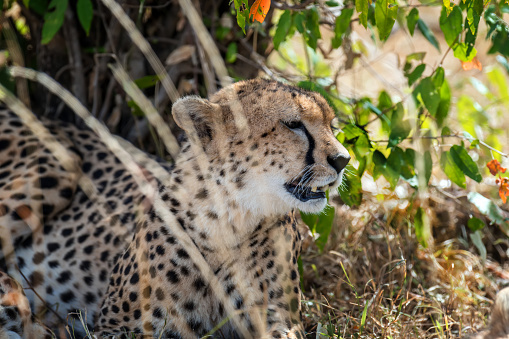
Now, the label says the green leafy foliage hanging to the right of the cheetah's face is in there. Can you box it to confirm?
[233,0,509,249]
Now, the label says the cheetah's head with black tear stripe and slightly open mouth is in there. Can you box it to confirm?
[173,79,350,215]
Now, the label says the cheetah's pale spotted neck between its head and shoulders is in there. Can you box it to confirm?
[162,148,289,248]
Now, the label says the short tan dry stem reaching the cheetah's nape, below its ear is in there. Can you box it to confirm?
[110,64,179,160]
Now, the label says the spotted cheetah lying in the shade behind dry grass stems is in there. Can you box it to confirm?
[0,79,350,339]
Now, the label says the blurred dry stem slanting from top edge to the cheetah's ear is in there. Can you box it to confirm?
[101,0,179,102]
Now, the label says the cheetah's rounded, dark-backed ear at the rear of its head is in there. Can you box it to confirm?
[172,96,221,144]
